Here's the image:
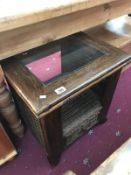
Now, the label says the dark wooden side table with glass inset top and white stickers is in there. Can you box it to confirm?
[3,33,130,165]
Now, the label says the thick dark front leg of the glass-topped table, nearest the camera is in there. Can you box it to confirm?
[41,108,63,166]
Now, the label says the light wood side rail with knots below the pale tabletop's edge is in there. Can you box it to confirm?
[0,0,131,60]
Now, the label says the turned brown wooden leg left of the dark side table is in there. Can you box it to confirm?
[0,73,24,137]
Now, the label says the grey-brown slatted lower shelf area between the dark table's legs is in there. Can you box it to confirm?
[61,90,102,146]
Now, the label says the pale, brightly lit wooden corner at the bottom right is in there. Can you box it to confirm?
[90,138,131,175]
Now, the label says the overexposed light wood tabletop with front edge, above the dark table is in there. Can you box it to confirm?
[0,0,115,31]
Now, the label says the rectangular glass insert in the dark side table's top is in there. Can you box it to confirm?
[22,36,106,85]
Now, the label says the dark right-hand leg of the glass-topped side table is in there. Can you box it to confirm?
[98,70,121,123]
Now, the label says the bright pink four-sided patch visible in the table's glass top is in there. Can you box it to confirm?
[26,51,62,82]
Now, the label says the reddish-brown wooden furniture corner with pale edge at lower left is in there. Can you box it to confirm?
[0,123,17,166]
